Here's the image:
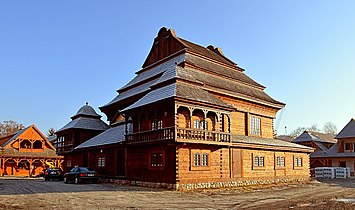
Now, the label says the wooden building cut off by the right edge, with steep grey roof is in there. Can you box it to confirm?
[312,119,355,176]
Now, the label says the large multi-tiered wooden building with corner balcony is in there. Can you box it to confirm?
[64,27,313,189]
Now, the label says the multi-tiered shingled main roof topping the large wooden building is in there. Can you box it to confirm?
[100,28,285,114]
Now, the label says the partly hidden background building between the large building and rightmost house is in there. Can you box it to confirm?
[292,131,337,171]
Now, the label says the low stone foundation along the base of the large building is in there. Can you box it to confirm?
[101,177,310,191]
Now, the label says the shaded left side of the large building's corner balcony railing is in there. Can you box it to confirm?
[126,127,174,143]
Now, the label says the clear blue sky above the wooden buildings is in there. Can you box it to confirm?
[0,0,355,134]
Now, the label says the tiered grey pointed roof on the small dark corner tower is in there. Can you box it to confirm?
[56,103,109,133]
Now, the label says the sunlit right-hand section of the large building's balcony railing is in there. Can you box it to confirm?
[176,128,230,142]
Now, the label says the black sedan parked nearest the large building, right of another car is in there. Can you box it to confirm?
[64,167,99,184]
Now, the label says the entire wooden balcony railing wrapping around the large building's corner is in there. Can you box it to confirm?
[126,127,230,144]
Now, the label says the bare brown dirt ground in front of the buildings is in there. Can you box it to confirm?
[0,177,355,209]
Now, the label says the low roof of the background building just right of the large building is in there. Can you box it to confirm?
[292,131,337,144]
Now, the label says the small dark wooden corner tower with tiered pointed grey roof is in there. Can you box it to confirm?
[54,103,109,171]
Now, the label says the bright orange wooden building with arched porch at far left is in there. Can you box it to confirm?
[0,125,63,176]
